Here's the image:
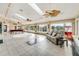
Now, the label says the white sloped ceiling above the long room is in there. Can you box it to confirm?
[0,3,79,22]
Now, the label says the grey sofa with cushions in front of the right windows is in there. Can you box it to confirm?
[46,32,64,45]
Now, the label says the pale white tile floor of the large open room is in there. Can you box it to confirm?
[0,33,70,56]
